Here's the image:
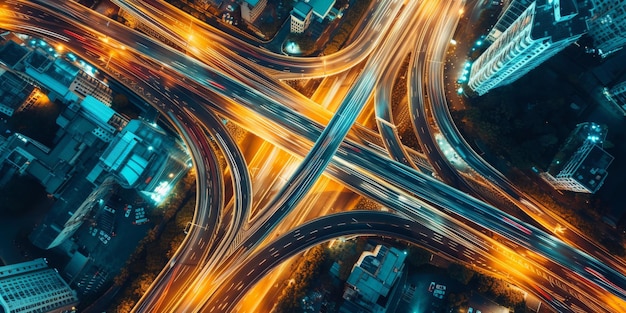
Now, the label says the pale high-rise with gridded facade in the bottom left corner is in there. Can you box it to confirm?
[0,259,78,313]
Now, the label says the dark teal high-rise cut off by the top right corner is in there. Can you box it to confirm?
[587,0,626,56]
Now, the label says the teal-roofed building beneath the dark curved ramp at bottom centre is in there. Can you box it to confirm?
[339,245,406,313]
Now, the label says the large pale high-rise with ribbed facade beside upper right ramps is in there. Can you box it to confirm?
[468,0,588,95]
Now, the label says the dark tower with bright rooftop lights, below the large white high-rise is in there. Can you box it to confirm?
[540,123,613,193]
